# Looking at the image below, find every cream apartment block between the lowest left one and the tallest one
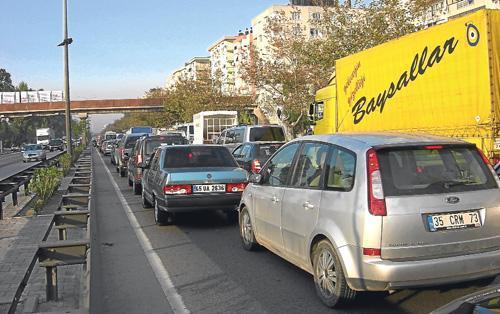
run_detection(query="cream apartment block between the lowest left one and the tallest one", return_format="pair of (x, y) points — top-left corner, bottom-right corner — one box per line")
(208, 36), (237, 95)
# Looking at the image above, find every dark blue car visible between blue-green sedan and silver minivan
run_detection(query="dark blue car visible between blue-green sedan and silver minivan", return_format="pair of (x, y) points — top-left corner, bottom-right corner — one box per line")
(233, 142), (285, 173)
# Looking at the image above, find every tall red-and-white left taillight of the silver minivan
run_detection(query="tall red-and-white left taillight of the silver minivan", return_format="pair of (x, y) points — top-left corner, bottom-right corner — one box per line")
(366, 149), (387, 216)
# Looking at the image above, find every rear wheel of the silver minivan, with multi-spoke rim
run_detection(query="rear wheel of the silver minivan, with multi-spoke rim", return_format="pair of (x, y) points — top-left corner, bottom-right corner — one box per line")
(312, 240), (356, 307)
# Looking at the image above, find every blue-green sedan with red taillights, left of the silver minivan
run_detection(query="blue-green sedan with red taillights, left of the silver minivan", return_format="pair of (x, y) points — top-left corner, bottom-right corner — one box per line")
(142, 145), (248, 225)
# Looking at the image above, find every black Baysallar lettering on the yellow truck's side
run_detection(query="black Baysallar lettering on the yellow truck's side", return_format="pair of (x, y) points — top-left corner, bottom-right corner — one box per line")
(351, 37), (459, 124)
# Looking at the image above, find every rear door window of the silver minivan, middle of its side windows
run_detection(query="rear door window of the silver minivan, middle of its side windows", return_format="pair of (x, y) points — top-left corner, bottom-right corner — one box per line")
(292, 143), (329, 188)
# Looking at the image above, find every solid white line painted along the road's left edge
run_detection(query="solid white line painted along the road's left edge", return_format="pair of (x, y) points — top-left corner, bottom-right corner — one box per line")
(98, 153), (190, 313)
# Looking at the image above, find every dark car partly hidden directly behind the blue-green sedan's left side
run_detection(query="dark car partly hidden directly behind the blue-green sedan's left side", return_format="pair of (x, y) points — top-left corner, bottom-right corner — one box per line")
(127, 135), (188, 195)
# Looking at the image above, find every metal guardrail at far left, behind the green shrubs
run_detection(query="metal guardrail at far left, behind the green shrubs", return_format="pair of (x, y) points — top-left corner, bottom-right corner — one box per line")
(0, 151), (66, 220)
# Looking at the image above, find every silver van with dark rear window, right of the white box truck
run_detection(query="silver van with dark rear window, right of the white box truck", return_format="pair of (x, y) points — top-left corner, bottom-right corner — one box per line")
(214, 124), (285, 151)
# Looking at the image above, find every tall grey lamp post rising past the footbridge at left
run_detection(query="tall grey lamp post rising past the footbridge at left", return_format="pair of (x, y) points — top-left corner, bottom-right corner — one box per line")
(58, 0), (73, 157)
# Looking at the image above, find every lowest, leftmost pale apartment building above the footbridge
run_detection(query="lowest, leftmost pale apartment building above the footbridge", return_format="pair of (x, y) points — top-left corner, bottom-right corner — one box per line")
(165, 57), (210, 89)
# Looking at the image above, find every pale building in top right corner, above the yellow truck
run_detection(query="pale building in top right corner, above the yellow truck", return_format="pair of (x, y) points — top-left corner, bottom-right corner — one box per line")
(419, 0), (500, 27)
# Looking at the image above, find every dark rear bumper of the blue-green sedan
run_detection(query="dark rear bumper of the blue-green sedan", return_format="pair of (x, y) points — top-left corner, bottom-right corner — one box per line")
(158, 193), (241, 212)
